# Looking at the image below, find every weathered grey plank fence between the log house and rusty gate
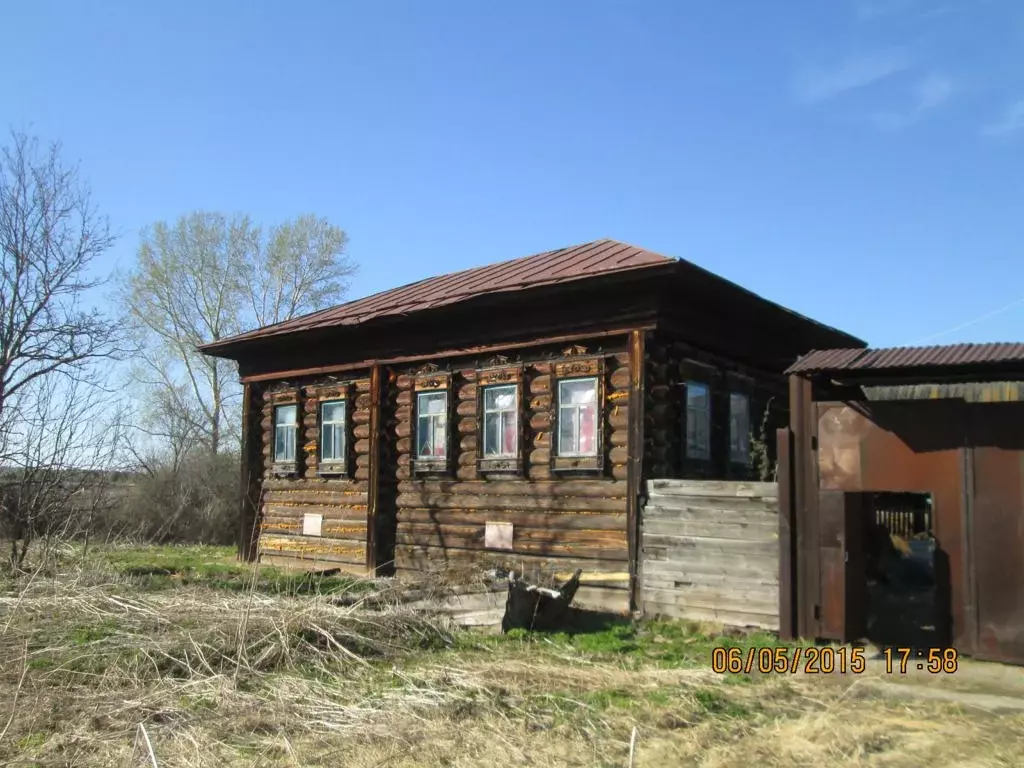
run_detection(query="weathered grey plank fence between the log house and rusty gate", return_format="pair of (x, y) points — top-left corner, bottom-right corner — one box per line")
(640, 480), (779, 630)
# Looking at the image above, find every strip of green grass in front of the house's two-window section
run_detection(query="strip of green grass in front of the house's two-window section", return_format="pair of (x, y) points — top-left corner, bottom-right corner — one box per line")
(94, 546), (369, 595)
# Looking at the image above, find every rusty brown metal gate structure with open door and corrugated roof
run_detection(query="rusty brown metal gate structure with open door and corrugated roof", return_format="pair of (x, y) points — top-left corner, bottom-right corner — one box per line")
(778, 344), (1024, 663)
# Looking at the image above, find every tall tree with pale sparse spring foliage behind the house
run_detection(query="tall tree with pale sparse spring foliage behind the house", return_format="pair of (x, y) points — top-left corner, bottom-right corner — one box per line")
(121, 212), (354, 462)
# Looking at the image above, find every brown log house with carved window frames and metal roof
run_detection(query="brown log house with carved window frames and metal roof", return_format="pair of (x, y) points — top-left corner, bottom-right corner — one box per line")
(203, 240), (863, 609)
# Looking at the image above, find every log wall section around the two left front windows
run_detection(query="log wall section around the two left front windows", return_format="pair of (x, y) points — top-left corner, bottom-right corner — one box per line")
(259, 379), (371, 572)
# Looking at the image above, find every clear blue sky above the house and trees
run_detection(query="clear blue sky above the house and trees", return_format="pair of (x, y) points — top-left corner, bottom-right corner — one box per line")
(0, 0), (1024, 345)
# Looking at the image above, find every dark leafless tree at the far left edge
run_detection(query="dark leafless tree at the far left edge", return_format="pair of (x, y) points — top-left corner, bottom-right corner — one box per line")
(0, 132), (119, 566)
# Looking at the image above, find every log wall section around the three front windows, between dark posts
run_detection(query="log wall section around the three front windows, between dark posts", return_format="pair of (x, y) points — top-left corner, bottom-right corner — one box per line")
(394, 351), (630, 610)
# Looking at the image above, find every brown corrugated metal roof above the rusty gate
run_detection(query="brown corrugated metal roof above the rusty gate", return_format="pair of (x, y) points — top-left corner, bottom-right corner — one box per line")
(786, 343), (1024, 374)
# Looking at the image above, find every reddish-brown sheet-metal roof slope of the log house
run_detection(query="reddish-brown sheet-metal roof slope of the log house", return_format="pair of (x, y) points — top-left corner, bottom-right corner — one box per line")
(200, 240), (676, 350)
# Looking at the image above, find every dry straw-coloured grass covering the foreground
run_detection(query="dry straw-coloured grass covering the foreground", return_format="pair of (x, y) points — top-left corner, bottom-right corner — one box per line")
(0, 548), (1024, 767)
